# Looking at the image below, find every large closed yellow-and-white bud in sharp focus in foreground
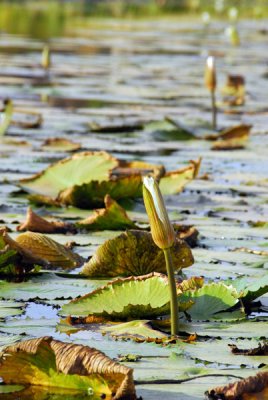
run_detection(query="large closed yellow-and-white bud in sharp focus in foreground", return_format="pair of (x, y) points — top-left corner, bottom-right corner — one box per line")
(143, 177), (175, 250)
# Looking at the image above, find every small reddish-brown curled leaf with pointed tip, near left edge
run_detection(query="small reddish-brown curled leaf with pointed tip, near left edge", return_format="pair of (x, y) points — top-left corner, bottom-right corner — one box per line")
(17, 207), (76, 233)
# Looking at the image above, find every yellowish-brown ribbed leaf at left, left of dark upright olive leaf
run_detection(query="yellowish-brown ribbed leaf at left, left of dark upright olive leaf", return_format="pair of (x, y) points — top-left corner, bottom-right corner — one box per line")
(16, 232), (82, 268)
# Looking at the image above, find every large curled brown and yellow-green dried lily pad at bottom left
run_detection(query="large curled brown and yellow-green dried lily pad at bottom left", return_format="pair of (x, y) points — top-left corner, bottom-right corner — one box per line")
(0, 337), (136, 400)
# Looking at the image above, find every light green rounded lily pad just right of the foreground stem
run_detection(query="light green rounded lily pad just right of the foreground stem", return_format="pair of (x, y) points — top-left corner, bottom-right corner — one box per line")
(180, 282), (238, 320)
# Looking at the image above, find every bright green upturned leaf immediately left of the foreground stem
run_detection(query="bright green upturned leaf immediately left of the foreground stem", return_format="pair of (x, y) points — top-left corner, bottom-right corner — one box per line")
(60, 273), (170, 319)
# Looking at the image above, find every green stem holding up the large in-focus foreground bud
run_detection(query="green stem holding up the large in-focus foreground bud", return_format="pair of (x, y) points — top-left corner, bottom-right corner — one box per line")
(163, 248), (179, 336)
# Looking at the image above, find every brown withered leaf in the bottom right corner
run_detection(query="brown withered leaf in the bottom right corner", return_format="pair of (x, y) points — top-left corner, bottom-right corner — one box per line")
(206, 372), (268, 400)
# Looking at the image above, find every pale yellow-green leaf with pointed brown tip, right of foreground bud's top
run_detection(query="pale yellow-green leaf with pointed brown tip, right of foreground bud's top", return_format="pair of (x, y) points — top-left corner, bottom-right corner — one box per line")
(159, 159), (201, 195)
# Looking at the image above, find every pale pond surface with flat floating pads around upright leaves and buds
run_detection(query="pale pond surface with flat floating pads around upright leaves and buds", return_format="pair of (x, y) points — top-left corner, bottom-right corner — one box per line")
(0, 5), (268, 400)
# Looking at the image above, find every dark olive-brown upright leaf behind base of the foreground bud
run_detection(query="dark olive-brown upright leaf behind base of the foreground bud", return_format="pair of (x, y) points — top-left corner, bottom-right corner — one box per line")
(82, 230), (194, 277)
